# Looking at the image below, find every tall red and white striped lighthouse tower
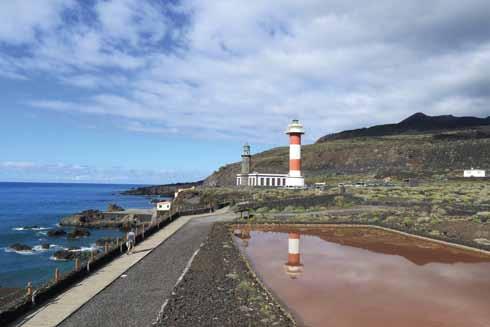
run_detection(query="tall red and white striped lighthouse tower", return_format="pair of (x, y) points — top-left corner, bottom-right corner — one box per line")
(286, 119), (305, 188)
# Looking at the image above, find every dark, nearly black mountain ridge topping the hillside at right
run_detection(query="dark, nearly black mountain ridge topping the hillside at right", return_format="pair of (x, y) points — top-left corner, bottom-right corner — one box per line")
(317, 112), (490, 143)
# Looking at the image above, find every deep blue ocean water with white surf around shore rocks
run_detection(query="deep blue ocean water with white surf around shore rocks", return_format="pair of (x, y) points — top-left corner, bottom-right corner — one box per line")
(0, 183), (152, 288)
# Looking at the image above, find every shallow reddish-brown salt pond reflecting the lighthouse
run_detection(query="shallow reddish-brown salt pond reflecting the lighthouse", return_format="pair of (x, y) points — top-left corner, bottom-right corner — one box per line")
(233, 226), (490, 327)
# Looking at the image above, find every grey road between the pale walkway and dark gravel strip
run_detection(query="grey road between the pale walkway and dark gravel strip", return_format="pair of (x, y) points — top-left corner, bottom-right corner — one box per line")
(60, 213), (233, 327)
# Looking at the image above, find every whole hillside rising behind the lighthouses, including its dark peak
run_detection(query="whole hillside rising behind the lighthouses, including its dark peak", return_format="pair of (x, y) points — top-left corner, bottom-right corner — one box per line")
(204, 114), (490, 186)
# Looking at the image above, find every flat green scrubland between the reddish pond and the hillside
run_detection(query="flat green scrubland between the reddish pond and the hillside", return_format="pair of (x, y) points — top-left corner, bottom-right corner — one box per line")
(230, 180), (490, 249)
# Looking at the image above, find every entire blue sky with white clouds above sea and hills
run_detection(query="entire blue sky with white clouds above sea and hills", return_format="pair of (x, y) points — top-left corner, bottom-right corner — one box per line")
(0, 0), (490, 184)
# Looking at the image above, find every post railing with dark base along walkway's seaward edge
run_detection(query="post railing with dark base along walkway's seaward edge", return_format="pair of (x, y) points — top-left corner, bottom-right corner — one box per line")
(0, 203), (229, 326)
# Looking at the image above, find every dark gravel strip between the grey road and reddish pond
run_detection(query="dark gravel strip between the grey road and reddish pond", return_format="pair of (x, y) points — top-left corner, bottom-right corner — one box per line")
(159, 223), (296, 326)
